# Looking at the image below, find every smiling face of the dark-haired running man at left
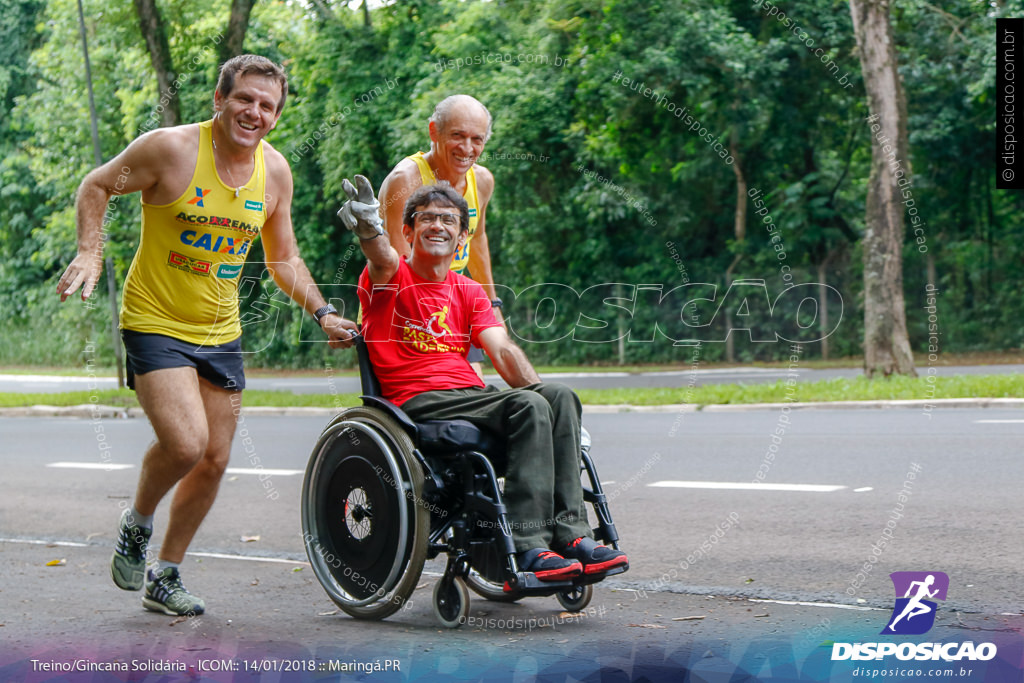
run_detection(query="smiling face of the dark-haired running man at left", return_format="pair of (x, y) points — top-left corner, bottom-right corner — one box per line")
(213, 74), (283, 148)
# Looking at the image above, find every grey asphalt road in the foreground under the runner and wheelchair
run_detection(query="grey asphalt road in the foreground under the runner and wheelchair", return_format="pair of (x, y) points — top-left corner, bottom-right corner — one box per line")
(0, 409), (1024, 681)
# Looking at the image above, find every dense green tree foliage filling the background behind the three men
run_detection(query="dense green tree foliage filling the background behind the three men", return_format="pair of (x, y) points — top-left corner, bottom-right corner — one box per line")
(0, 0), (1007, 367)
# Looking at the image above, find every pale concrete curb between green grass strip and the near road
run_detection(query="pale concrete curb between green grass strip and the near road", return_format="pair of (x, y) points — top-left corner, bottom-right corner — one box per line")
(0, 398), (1024, 420)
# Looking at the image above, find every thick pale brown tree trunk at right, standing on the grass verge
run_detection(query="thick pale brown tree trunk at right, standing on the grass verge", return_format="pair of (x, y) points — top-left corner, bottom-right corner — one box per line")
(850, 0), (918, 378)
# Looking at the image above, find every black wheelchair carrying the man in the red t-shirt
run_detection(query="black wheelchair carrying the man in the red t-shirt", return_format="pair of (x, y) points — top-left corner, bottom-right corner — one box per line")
(302, 337), (629, 628)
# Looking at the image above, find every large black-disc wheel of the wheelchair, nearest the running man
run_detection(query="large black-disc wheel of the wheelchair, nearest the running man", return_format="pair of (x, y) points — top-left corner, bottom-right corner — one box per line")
(302, 408), (430, 620)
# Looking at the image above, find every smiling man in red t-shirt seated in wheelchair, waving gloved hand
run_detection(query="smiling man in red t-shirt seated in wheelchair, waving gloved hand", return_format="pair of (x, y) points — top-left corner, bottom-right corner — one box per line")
(339, 176), (628, 581)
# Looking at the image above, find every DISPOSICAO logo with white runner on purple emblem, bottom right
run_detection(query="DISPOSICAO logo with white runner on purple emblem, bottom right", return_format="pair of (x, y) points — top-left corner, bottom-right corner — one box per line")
(831, 571), (996, 661)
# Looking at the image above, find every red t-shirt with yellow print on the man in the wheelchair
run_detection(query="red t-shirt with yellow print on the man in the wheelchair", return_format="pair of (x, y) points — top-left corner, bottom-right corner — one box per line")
(359, 258), (501, 405)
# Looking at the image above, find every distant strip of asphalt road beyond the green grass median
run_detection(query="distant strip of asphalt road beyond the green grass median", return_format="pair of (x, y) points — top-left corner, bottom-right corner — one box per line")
(0, 364), (1024, 393)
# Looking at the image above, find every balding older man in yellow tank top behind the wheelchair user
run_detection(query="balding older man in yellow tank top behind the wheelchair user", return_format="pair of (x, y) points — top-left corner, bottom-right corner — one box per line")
(379, 95), (502, 377)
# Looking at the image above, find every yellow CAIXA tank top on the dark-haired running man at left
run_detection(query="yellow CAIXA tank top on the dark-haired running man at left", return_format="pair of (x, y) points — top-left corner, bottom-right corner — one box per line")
(121, 121), (266, 345)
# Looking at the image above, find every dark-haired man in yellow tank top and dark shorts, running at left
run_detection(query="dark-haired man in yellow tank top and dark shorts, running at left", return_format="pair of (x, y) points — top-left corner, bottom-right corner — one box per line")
(57, 55), (355, 615)
